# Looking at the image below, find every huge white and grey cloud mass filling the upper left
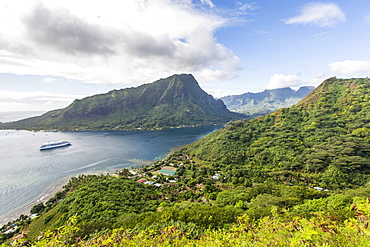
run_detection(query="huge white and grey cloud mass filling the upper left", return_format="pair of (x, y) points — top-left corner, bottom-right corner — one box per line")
(0, 0), (239, 84)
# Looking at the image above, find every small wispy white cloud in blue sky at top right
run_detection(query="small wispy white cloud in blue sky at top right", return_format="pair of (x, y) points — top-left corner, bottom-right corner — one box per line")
(283, 3), (346, 27)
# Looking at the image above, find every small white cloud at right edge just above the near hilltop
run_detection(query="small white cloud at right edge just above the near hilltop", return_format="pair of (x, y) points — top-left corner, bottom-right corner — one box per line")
(328, 60), (370, 78)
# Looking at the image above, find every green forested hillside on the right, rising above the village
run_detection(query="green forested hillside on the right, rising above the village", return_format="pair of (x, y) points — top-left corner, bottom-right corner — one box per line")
(181, 78), (370, 189)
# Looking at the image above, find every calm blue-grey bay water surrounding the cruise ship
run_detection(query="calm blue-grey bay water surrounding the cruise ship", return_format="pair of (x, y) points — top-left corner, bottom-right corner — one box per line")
(0, 126), (222, 225)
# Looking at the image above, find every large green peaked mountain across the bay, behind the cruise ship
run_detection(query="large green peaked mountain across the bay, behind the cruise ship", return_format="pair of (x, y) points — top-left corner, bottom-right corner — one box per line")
(3, 74), (243, 130)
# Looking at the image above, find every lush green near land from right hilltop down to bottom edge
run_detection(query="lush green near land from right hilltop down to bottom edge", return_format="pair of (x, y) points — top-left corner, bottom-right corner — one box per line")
(0, 78), (370, 246)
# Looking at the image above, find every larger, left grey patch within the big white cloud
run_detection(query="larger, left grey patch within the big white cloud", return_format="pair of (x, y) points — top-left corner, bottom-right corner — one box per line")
(23, 5), (117, 54)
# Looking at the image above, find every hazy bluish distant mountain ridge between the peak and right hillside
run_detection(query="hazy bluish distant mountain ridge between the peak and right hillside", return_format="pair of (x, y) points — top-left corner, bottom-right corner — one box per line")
(221, 86), (315, 117)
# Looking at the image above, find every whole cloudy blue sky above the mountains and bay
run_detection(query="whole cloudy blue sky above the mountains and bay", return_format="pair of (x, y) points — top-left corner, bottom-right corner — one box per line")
(0, 0), (370, 112)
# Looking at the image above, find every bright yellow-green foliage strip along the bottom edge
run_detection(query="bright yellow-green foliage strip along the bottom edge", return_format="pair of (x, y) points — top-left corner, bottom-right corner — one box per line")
(9, 198), (370, 247)
